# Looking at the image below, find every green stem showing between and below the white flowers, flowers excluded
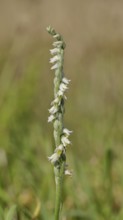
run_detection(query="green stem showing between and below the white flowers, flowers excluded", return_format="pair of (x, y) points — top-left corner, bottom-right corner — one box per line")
(54, 42), (65, 220)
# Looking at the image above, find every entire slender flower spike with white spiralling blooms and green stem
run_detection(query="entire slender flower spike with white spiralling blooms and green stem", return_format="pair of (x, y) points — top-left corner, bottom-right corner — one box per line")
(47, 26), (72, 220)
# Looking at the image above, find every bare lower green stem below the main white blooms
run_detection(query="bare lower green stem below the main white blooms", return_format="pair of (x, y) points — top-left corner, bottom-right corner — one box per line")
(54, 162), (65, 220)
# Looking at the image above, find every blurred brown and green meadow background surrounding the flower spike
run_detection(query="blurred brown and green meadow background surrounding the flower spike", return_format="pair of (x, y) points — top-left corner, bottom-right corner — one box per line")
(0, 0), (123, 220)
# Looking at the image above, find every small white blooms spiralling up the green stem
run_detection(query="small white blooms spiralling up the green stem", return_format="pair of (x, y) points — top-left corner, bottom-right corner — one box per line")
(48, 34), (72, 175)
